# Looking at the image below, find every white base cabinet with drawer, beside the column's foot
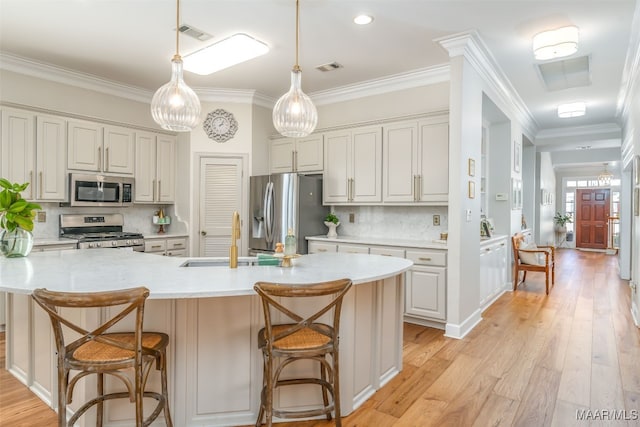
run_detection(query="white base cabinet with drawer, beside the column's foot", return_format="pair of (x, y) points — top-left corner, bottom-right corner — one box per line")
(405, 249), (447, 324)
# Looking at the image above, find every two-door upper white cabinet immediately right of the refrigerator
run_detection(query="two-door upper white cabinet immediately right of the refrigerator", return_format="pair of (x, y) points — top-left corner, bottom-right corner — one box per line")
(323, 126), (382, 204)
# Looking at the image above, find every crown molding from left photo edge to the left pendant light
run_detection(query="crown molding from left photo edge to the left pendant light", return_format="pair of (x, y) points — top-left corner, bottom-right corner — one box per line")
(0, 52), (153, 104)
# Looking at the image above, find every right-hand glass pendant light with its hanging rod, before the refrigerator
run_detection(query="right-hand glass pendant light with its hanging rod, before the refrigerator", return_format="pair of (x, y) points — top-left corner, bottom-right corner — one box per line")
(273, 0), (318, 138)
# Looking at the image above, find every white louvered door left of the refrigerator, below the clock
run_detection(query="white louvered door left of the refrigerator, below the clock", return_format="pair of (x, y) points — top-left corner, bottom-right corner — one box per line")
(200, 157), (243, 257)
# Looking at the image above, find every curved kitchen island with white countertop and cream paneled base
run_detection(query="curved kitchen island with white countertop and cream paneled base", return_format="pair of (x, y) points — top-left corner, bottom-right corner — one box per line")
(0, 249), (411, 426)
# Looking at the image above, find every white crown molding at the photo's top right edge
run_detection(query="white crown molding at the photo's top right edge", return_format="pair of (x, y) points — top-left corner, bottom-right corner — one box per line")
(616, 3), (640, 123)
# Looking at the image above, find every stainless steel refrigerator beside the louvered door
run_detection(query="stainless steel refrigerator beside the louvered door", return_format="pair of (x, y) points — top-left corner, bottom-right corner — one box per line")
(249, 173), (329, 254)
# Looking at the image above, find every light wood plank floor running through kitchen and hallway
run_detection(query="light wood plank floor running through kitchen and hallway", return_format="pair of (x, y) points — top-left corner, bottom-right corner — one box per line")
(0, 250), (640, 427)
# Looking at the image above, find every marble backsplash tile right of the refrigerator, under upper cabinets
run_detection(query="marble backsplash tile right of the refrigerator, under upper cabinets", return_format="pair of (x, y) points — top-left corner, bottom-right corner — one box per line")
(334, 206), (448, 240)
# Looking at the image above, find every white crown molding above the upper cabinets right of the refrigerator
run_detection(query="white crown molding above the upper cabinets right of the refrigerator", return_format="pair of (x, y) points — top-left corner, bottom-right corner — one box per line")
(309, 64), (450, 105)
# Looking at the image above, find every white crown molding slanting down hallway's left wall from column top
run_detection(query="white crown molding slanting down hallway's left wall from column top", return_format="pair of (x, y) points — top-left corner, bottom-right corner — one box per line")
(434, 30), (539, 139)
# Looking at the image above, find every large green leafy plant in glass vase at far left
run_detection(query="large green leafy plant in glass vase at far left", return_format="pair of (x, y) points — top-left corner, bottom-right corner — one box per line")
(0, 178), (42, 231)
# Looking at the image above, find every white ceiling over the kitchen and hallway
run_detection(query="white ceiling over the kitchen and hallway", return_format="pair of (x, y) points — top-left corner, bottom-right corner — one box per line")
(0, 0), (640, 155)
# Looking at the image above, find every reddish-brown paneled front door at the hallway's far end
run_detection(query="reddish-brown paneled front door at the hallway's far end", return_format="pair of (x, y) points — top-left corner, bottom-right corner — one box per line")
(576, 188), (610, 249)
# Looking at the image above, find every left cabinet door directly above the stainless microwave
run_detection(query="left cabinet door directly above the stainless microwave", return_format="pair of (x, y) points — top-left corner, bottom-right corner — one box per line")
(67, 120), (103, 172)
